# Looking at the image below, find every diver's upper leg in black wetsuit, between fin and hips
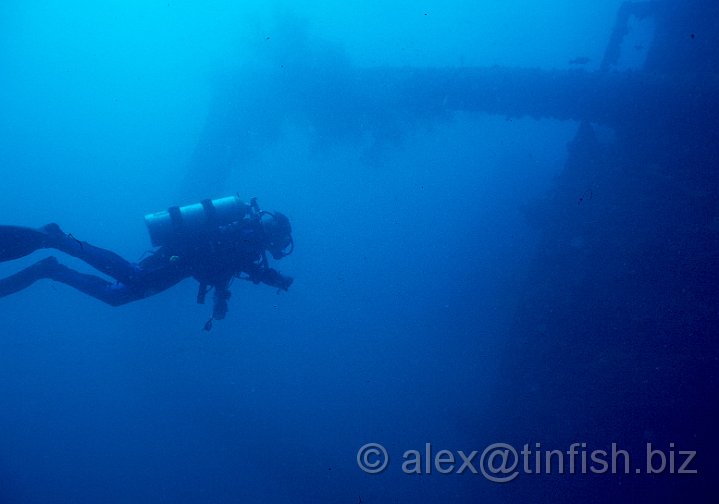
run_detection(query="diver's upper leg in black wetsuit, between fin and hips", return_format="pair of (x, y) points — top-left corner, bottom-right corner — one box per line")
(42, 223), (138, 284)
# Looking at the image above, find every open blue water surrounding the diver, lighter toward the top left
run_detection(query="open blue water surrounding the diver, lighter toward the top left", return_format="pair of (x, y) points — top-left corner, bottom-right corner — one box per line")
(0, 0), (716, 504)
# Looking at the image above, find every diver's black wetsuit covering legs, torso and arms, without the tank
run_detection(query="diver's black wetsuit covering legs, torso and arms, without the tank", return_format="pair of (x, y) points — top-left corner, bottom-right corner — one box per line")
(0, 219), (292, 319)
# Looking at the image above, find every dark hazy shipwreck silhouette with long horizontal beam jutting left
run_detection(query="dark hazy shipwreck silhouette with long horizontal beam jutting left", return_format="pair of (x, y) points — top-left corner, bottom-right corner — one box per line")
(187, 0), (719, 504)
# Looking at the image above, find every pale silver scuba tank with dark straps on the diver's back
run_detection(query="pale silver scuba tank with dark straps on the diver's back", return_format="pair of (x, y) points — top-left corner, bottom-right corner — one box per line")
(145, 196), (257, 247)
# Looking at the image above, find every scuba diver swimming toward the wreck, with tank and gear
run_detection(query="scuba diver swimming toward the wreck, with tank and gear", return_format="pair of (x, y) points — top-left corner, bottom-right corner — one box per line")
(0, 196), (294, 331)
